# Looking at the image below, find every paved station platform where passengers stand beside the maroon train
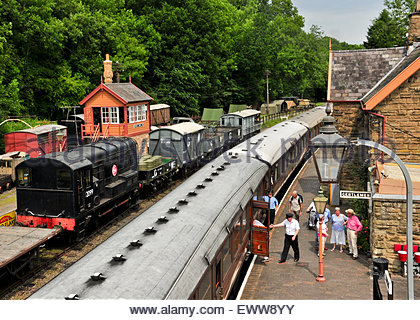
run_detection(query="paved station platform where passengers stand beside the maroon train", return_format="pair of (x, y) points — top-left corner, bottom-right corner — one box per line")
(238, 160), (420, 300)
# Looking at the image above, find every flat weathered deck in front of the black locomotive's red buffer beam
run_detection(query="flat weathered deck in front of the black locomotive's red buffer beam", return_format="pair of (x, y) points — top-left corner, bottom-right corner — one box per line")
(0, 226), (61, 275)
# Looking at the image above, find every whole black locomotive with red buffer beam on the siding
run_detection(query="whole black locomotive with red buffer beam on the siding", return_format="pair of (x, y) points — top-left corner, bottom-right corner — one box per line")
(16, 138), (138, 234)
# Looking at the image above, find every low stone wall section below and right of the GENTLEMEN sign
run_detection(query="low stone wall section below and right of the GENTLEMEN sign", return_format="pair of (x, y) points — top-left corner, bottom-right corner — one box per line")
(370, 200), (420, 272)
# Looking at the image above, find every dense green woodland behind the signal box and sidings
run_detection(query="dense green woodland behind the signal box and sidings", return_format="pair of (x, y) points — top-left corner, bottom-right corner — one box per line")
(0, 0), (364, 120)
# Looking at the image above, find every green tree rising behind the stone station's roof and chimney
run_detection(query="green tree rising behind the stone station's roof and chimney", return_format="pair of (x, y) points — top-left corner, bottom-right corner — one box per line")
(364, 0), (416, 49)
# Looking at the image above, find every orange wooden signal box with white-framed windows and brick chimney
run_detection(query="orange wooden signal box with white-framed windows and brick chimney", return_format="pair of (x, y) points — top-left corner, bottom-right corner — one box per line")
(79, 54), (153, 153)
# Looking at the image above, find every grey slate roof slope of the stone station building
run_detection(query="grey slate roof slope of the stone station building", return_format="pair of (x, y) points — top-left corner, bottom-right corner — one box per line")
(330, 47), (405, 100)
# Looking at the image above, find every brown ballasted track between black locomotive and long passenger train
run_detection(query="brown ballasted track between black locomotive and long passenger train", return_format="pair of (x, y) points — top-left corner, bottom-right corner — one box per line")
(0, 179), (184, 300)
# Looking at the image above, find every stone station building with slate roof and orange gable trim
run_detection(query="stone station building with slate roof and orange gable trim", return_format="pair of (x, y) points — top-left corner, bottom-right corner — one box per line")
(327, 0), (420, 271)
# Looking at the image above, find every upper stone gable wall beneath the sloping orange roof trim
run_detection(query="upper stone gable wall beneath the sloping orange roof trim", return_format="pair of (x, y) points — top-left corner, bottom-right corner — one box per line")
(370, 70), (420, 163)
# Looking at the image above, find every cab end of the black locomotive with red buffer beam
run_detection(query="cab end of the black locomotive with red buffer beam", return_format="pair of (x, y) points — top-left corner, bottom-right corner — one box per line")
(16, 153), (94, 230)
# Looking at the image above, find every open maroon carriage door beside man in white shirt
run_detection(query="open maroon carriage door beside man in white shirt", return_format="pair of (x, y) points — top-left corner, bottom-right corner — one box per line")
(250, 198), (270, 257)
